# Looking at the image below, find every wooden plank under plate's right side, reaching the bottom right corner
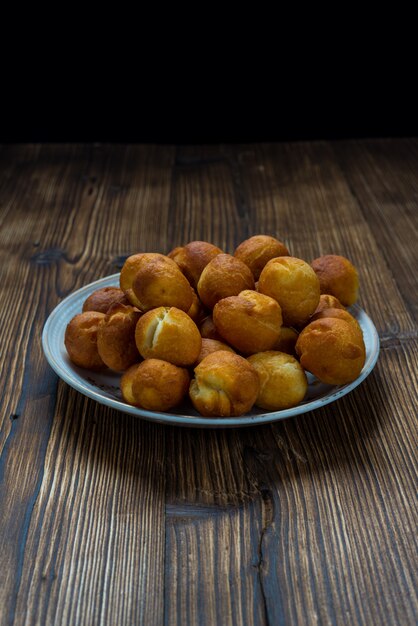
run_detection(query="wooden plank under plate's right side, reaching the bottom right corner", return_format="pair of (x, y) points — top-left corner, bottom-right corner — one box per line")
(232, 144), (417, 624)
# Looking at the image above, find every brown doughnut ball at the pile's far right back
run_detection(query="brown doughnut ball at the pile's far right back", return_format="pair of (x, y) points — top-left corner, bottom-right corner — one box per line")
(311, 254), (359, 306)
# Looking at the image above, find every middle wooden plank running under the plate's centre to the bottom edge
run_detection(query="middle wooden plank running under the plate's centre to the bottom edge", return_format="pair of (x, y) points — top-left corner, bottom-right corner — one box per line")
(165, 152), (264, 625)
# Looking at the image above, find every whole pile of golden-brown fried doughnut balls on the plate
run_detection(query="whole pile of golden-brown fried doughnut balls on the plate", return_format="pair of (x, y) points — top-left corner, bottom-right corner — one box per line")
(65, 235), (366, 417)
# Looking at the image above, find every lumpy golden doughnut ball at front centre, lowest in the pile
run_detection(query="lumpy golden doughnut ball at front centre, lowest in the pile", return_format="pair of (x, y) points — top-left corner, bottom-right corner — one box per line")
(189, 351), (260, 417)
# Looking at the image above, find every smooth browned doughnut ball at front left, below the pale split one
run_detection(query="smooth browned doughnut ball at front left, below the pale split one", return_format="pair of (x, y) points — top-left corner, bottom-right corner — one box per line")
(120, 359), (190, 411)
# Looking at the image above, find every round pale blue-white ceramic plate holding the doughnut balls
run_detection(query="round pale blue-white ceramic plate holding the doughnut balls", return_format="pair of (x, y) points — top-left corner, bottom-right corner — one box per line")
(42, 274), (379, 428)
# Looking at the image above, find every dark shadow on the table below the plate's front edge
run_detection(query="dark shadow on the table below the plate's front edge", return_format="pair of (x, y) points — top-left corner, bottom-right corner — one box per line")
(63, 360), (388, 512)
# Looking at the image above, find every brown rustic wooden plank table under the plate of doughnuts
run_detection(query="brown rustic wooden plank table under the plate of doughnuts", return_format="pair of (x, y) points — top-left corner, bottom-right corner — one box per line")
(0, 139), (418, 626)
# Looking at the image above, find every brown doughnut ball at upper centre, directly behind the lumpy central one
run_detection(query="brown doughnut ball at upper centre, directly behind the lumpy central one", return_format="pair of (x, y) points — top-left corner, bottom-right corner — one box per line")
(197, 254), (254, 309)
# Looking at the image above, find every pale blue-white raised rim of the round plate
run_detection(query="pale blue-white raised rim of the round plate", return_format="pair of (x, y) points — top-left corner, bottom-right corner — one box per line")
(42, 273), (380, 428)
